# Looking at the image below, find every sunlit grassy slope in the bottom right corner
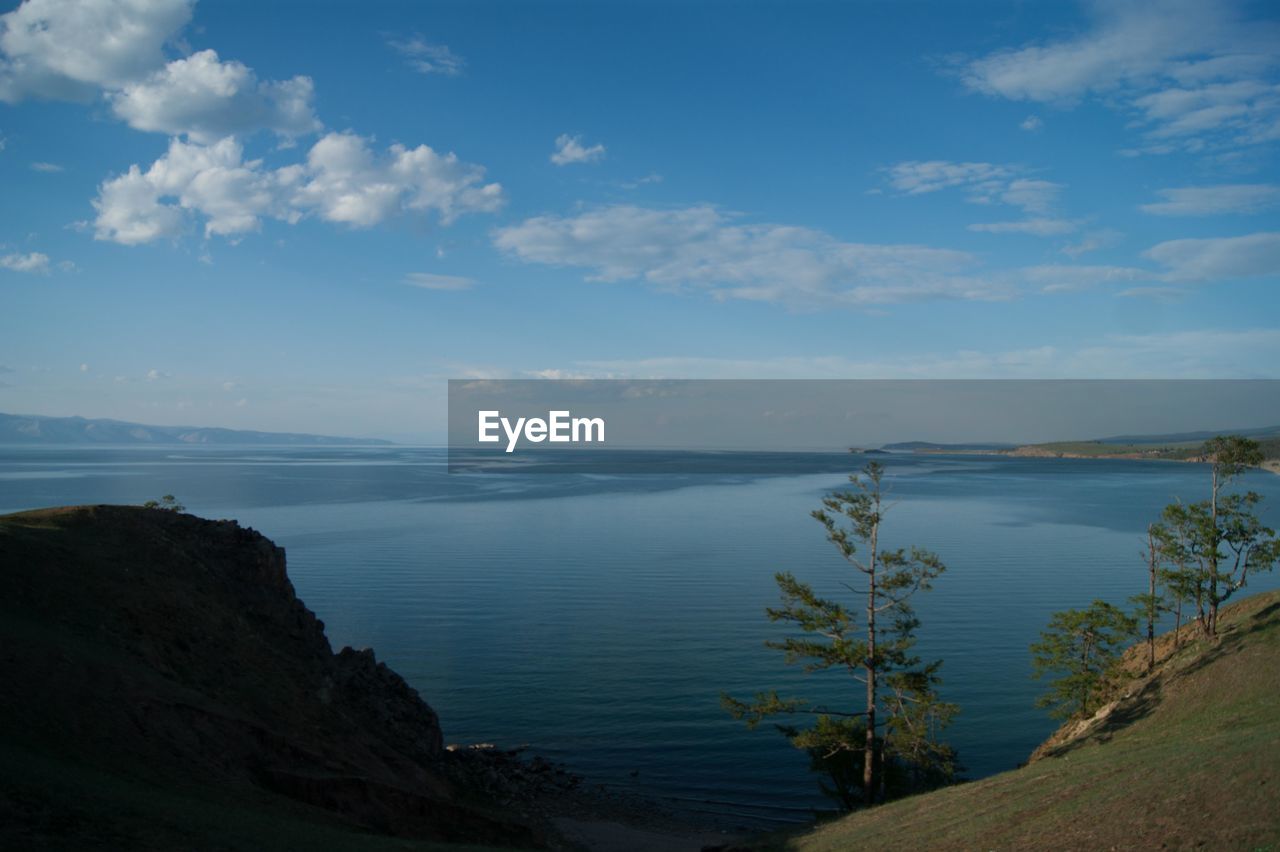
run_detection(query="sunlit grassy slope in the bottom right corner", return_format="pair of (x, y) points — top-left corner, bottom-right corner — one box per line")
(764, 592), (1280, 852)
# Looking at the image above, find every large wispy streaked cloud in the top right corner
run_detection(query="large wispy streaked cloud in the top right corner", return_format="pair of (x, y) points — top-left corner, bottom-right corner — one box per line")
(963, 0), (1280, 151)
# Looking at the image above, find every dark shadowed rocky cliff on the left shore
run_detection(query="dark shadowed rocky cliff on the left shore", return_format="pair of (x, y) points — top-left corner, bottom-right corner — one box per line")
(0, 505), (538, 847)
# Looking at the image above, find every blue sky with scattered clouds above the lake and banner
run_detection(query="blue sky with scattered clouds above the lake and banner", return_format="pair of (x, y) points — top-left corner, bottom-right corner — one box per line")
(0, 0), (1280, 440)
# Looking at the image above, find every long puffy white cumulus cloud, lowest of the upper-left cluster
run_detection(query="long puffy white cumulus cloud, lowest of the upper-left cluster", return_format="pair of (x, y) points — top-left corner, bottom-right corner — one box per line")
(93, 133), (503, 246)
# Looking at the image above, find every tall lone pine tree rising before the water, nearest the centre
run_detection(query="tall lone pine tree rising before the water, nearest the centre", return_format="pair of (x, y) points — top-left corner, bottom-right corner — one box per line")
(721, 462), (957, 807)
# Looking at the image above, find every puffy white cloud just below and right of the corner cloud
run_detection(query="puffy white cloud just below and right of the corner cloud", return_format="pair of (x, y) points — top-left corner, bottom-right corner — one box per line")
(108, 50), (320, 143)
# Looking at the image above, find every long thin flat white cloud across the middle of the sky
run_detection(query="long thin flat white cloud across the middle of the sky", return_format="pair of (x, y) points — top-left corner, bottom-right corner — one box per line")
(494, 205), (1014, 307)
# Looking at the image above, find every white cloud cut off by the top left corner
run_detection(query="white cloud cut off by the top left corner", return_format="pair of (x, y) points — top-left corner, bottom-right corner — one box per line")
(0, 0), (193, 104)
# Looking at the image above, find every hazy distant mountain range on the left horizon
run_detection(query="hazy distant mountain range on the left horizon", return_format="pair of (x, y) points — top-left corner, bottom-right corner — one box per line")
(0, 413), (392, 446)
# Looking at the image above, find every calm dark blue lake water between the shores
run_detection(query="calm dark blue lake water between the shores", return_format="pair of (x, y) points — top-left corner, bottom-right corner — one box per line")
(0, 446), (1280, 817)
